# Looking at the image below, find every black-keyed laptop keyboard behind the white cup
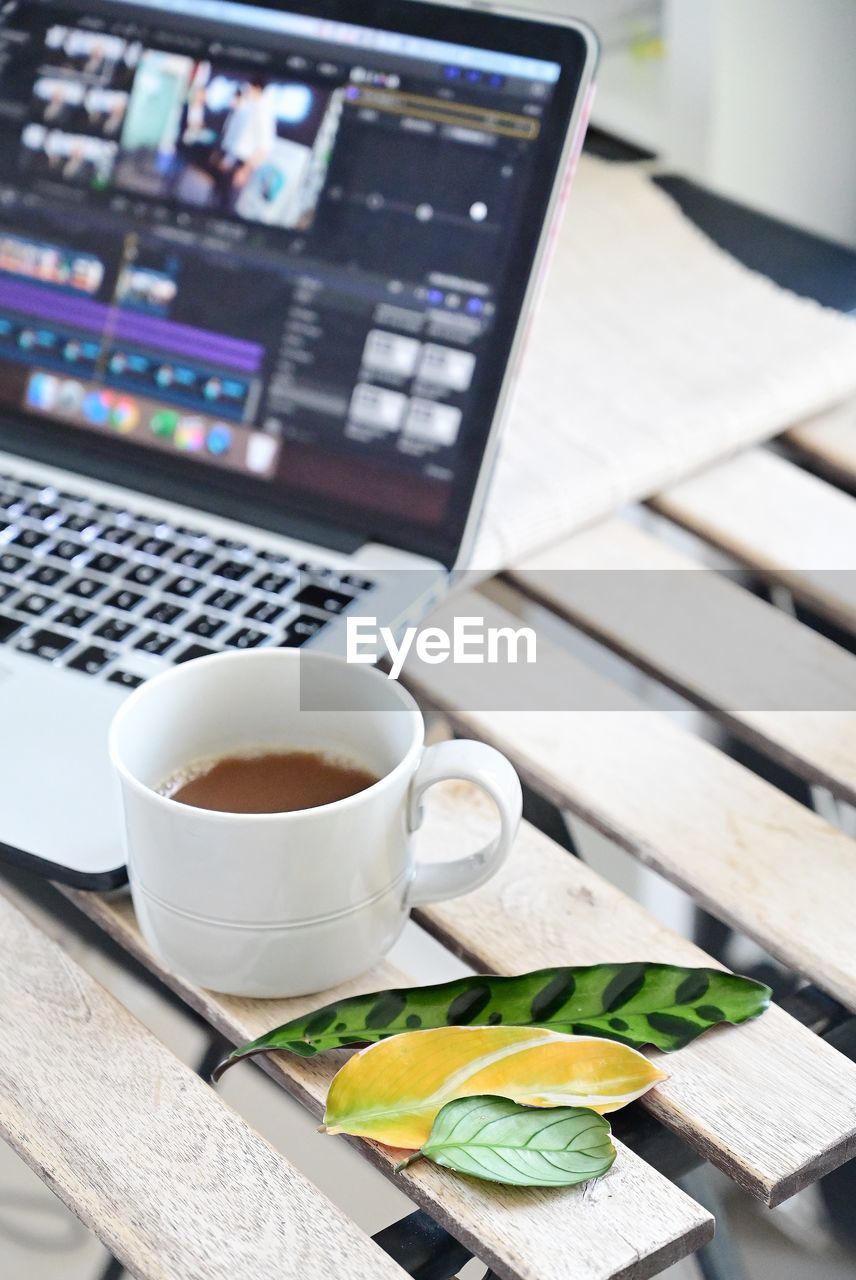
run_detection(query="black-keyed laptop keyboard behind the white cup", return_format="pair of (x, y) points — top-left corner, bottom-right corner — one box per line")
(0, 476), (374, 689)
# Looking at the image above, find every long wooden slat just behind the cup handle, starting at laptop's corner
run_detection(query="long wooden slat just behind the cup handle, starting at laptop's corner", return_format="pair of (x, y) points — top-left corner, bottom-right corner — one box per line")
(406, 595), (856, 1009)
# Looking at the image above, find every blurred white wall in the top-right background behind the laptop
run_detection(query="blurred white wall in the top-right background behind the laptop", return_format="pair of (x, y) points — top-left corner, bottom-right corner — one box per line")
(493, 0), (856, 244)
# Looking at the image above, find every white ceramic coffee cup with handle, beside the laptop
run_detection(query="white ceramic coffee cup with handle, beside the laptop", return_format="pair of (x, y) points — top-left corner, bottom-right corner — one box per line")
(110, 649), (522, 996)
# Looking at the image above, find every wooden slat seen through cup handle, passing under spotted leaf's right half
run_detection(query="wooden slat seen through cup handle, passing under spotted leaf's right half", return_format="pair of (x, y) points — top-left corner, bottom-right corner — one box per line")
(422, 787), (856, 1204)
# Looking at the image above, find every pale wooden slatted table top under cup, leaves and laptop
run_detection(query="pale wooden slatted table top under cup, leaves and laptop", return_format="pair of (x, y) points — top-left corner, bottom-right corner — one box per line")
(0, 167), (856, 1280)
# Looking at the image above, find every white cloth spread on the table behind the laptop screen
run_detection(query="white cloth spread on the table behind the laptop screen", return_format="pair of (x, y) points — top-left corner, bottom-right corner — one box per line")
(472, 157), (856, 570)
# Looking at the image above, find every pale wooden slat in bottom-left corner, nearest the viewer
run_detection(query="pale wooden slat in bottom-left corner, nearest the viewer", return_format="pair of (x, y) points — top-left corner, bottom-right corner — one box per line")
(0, 895), (404, 1280)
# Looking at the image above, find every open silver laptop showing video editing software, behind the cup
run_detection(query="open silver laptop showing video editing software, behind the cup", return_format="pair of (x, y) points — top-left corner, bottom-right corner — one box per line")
(0, 0), (596, 890)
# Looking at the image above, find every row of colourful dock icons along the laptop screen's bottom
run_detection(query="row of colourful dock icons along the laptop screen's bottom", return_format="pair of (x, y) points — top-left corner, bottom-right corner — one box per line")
(24, 369), (280, 479)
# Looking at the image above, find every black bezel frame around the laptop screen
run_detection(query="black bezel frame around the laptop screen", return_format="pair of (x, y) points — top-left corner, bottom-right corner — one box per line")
(0, 0), (592, 567)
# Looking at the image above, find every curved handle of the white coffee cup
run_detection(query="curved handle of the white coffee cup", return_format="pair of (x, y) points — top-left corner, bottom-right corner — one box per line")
(407, 741), (523, 906)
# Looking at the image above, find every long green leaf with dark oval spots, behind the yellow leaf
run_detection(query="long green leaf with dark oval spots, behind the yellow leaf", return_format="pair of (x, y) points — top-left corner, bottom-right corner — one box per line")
(214, 963), (772, 1079)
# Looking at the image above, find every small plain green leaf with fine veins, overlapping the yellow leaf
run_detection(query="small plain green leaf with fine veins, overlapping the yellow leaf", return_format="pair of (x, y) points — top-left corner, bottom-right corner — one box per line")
(399, 1097), (615, 1187)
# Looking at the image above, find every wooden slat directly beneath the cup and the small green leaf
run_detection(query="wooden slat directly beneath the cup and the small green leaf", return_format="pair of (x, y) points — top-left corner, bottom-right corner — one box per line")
(64, 890), (713, 1280)
